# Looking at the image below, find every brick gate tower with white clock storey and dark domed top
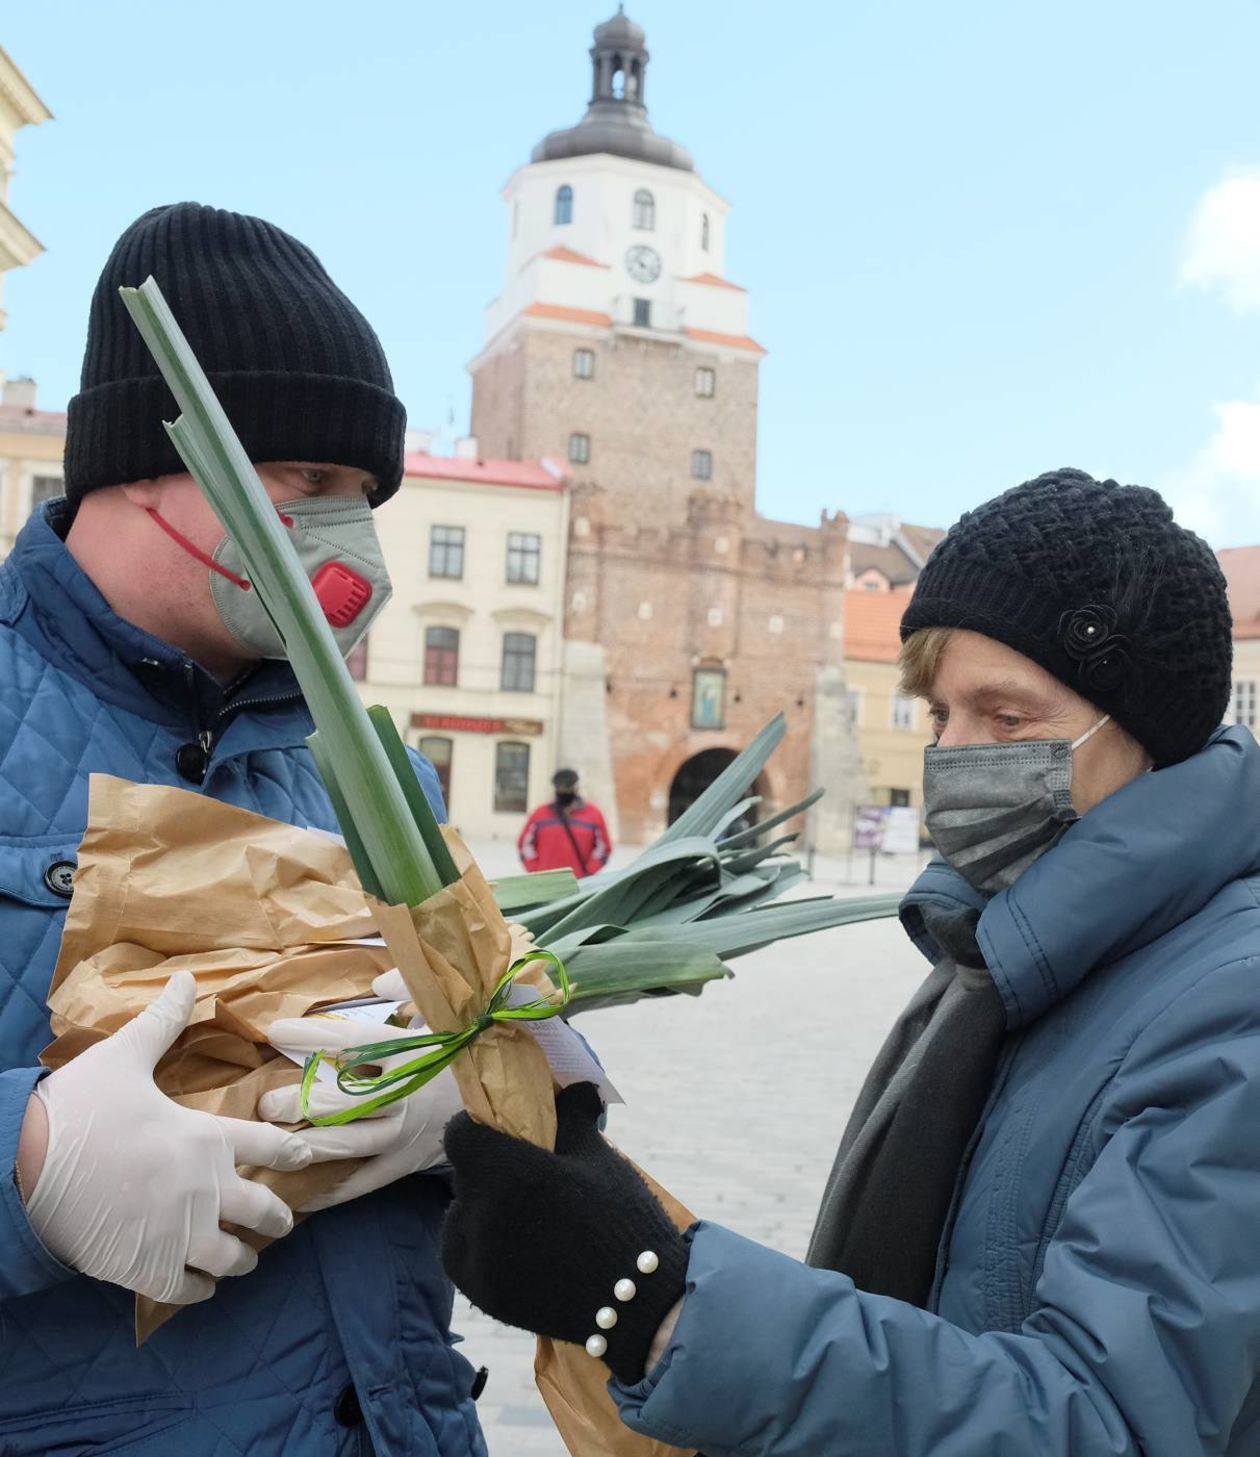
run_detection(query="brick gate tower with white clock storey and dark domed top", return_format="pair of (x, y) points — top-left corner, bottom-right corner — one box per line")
(470, 13), (861, 848)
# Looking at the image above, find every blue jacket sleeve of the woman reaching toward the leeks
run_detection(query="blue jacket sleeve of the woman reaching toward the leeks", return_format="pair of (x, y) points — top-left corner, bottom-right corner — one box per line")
(613, 959), (1260, 1457)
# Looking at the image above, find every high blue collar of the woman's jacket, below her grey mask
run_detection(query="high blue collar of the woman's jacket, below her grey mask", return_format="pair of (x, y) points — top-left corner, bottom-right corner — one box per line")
(902, 729), (1260, 1029)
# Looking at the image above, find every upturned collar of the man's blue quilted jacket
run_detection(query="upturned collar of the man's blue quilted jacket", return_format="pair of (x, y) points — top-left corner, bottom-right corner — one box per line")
(0, 500), (300, 730)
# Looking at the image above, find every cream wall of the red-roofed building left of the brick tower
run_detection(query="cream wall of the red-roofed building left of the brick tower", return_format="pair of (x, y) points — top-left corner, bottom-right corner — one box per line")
(360, 456), (568, 839)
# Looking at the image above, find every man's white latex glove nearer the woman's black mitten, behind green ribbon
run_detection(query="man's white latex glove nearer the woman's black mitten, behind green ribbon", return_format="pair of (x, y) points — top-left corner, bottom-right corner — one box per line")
(258, 1002), (463, 1214)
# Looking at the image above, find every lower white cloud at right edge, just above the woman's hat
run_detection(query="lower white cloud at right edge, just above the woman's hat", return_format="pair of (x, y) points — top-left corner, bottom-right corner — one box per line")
(1159, 392), (1260, 548)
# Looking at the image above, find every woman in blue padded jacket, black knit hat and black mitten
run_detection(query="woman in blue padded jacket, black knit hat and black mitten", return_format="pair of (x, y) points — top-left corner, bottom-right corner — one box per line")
(444, 471), (1260, 1457)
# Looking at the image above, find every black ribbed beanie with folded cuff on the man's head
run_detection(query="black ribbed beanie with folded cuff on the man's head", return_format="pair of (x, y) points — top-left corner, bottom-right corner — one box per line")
(66, 203), (406, 504)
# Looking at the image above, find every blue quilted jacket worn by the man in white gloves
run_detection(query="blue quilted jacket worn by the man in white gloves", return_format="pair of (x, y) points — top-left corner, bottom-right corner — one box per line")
(0, 503), (485, 1457)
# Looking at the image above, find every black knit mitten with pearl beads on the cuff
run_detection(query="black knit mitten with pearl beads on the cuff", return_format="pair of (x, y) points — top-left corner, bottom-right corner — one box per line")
(441, 1083), (688, 1383)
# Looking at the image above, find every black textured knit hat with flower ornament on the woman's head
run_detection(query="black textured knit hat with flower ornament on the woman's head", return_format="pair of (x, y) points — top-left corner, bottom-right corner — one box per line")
(902, 471), (1232, 766)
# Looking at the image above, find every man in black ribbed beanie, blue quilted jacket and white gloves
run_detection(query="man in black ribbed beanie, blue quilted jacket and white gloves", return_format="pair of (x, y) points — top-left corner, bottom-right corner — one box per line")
(0, 203), (485, 1457)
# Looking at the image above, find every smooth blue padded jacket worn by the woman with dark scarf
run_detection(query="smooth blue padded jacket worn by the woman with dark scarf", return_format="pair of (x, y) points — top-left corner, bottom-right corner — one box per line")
(618, 729), (1260, 1457)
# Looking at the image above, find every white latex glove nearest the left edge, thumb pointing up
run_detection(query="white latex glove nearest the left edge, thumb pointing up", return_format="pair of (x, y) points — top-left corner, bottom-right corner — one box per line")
(26, 972), (310, 1305)
